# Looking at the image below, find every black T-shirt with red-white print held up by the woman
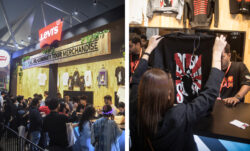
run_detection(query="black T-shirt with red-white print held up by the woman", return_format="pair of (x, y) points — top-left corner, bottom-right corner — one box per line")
(149, 33), (214, 103)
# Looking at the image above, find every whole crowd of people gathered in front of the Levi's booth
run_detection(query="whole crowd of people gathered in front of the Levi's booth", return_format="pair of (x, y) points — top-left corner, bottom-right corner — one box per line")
(0, 91), (125, 151)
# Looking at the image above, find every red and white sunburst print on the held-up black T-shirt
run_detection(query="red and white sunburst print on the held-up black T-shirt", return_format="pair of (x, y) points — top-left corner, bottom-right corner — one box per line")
(174, 53), (202, 103)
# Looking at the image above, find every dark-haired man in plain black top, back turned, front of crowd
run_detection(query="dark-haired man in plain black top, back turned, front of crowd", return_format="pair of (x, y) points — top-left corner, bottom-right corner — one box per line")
(43, 98), (71, 151)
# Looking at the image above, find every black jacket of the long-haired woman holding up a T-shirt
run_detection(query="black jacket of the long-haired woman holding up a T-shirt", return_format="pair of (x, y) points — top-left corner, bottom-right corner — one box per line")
(129, 59), (224, 151)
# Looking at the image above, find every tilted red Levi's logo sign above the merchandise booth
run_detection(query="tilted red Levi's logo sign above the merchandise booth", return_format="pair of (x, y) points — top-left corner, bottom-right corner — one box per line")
(39, 19), (63, 48)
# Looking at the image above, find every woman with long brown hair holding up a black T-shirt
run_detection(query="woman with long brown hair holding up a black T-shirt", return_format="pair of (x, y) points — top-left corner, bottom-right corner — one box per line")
(130, 36), (226, 151)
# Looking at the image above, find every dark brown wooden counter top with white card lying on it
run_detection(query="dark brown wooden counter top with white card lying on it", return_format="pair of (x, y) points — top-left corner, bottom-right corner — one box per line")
(194, 101), (250, 144)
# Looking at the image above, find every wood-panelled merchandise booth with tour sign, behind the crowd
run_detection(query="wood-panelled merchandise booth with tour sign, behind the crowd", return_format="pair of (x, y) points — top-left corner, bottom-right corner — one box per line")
(11, 6), (125, 107)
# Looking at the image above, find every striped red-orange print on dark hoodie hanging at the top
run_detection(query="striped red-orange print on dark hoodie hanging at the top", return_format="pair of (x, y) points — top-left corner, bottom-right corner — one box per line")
(194, 0), (208, 16)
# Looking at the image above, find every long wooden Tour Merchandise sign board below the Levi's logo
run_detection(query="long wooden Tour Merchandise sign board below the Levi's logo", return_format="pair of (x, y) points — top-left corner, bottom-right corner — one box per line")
(22, 30), (111, 69)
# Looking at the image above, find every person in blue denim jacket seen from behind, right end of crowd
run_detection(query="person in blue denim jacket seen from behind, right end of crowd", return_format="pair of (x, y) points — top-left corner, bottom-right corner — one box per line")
(91, 105), (122, 151)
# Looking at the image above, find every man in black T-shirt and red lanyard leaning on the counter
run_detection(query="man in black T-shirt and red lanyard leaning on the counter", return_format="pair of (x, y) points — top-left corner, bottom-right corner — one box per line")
(218, 44), (250, 105)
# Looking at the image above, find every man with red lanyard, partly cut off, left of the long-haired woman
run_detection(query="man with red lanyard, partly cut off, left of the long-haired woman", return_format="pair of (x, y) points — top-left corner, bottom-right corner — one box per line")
(129, 33), (143, 78)
